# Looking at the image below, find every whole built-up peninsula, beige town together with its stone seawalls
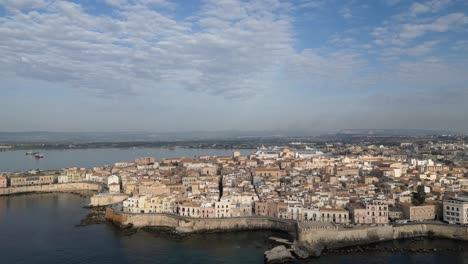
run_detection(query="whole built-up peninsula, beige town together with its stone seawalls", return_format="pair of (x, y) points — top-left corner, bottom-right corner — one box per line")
(0, 137), (468, 263)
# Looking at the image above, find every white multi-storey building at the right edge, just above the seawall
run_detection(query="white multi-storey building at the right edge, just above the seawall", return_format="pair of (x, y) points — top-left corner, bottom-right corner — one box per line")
(443, 196), (468, 225)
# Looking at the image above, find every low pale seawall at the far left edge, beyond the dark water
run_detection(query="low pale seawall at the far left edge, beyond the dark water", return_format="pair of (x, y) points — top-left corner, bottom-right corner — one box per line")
(0, 182), (101, 196)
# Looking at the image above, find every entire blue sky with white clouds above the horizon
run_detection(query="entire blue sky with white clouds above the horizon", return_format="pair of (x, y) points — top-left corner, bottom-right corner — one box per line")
(0, 0), (468, 133)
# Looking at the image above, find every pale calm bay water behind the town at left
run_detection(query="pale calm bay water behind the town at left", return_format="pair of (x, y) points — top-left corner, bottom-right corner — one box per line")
(0, 148), (255, 172)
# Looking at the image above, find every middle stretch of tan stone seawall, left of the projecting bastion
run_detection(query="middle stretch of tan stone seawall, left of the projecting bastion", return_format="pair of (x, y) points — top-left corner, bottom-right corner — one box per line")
(106, 208), (296, 236)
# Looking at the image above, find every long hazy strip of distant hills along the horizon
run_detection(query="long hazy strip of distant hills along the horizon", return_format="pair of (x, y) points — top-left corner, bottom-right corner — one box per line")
(0, 129), (454, 143)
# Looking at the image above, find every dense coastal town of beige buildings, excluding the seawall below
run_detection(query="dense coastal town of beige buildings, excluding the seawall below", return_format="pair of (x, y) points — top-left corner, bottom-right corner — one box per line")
(0, 136), (468, 226)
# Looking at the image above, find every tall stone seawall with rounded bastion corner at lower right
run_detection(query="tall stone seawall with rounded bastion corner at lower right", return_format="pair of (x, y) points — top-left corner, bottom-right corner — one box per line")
(297, 223), (468, 256)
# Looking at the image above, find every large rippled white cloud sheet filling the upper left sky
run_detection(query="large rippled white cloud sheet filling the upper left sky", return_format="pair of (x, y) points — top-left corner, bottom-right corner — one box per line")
(0, 0), (293, 98)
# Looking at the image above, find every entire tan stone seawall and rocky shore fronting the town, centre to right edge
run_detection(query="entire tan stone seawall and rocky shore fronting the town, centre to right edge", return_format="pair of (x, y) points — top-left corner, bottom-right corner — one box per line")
(106, 208), (468, 262)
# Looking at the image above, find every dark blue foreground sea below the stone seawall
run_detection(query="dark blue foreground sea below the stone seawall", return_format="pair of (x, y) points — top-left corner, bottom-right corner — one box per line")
(0, 193), (468, 264)
